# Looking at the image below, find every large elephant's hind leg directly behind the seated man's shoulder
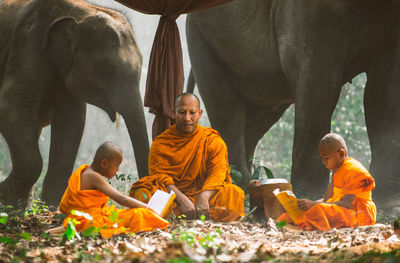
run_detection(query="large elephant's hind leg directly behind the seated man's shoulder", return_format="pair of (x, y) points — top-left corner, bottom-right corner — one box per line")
(187, 18), (250, 187)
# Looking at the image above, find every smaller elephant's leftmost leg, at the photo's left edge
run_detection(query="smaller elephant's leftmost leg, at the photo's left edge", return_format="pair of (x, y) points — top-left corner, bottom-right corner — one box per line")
(0, 125), (43, 209)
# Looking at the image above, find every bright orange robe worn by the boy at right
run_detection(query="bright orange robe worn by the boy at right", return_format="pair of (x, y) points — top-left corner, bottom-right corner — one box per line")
(278, 157), (376, 230)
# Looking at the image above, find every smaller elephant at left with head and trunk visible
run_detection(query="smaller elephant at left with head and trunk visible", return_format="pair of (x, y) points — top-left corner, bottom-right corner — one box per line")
(0, 0), (149, 210)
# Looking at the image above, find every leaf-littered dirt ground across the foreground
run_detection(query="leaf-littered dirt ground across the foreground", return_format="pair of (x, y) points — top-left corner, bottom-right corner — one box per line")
(0, 212), (400, 263)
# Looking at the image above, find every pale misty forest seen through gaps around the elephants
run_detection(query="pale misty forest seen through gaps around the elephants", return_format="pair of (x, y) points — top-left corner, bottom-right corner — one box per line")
(0, 0), (371, 199)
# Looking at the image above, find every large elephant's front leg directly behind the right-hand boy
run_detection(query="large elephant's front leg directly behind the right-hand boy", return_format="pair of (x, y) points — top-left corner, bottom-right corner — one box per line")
(291, 74), (341, 198)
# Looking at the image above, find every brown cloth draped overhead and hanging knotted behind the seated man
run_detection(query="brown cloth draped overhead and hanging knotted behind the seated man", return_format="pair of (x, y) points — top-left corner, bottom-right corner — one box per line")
(116, 0), (232, 139)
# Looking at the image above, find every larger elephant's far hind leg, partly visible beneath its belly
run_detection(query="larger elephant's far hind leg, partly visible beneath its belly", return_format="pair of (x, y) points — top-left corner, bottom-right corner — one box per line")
(245, 104), (290, 169)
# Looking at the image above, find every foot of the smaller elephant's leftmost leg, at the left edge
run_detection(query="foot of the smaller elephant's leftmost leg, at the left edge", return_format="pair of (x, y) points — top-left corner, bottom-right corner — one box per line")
(0, 177), (33, 210)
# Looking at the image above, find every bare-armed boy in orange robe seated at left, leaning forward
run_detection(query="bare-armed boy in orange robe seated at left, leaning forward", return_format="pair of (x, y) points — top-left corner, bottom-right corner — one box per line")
(60, 142), (169, 238)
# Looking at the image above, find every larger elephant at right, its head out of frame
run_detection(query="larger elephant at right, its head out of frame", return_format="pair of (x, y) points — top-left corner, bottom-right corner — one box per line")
(186, 0), (400, 214)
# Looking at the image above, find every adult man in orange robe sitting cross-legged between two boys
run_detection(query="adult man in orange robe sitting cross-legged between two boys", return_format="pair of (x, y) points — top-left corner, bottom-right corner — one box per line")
(130, 93), (244, 221)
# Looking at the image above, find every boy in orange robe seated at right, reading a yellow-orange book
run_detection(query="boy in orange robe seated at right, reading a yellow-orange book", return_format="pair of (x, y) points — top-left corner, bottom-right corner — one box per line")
(278, 133), (376, 230)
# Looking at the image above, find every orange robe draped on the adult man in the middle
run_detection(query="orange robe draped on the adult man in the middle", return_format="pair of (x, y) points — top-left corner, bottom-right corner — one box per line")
(130, 125), (244, 221)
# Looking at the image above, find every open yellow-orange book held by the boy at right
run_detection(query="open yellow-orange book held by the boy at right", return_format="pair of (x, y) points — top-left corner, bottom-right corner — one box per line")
(273, 188), (305, 224)
